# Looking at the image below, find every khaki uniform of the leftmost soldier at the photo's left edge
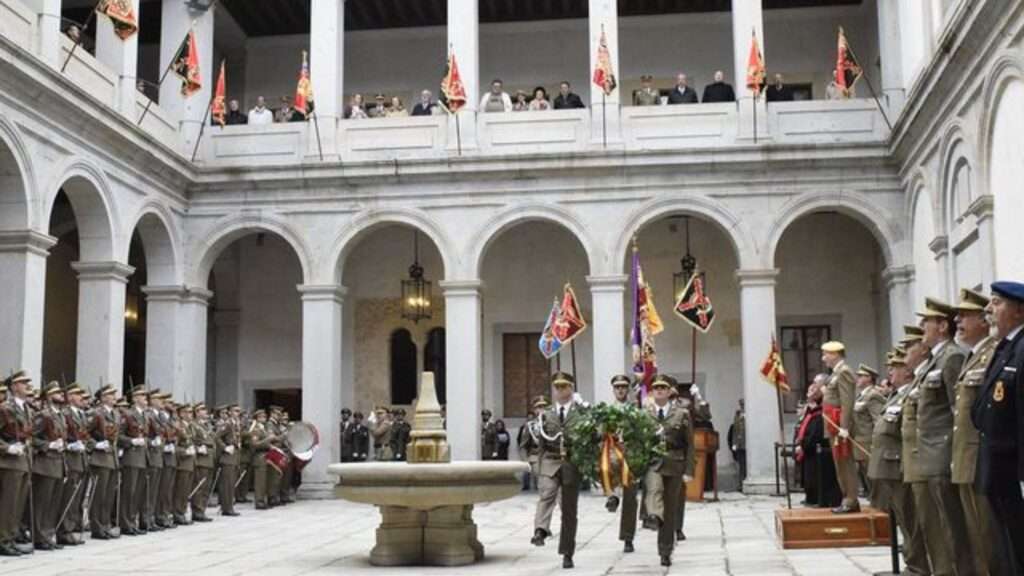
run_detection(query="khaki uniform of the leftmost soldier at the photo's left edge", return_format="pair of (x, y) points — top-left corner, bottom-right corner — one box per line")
(0, 397), (32, 547)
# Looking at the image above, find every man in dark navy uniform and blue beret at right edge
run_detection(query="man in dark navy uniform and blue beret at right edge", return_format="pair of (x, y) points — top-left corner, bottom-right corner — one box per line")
(971, 281), (1024, 574)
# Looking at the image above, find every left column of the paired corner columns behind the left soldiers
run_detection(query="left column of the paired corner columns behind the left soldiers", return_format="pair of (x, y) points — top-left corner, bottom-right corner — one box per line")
(142, 286), (188, 391)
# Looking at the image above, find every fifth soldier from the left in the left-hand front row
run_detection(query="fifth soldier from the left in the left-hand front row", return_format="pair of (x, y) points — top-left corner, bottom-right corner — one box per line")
(118, 385), (148, 536)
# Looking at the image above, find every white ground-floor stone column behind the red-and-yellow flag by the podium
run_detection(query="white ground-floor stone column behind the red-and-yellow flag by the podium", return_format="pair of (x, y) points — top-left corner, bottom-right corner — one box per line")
(736, 270), (780, 493)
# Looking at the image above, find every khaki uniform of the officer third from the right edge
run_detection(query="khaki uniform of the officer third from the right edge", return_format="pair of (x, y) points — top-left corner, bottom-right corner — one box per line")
(918, 340), (974, 575)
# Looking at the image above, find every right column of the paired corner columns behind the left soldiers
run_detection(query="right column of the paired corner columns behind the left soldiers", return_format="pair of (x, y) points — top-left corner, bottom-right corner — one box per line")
(174, 286), (213, 402)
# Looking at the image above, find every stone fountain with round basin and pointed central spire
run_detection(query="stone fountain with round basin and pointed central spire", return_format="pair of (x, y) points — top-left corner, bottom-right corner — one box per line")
(328, 372), (529, 566)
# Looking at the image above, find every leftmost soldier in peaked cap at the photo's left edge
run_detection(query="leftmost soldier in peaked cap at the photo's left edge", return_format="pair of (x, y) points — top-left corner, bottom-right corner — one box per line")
(0, 371), (32, 557)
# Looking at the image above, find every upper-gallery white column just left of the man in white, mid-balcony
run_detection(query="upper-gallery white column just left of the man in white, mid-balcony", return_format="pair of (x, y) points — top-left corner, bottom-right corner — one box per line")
(444, 0), (479, 151)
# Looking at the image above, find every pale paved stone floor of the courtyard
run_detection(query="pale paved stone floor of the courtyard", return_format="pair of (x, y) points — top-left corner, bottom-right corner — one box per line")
(0, 487), (890, 576)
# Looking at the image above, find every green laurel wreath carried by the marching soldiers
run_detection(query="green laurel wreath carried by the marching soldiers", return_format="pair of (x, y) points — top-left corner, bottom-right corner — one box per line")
(567, 402), (666, 483)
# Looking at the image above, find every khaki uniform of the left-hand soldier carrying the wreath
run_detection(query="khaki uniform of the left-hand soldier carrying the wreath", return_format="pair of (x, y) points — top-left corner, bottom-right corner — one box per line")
(534, 403), (580, 557)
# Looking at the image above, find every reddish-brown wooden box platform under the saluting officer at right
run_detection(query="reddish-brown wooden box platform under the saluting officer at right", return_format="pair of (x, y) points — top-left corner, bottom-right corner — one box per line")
(775, 507), (890, 548)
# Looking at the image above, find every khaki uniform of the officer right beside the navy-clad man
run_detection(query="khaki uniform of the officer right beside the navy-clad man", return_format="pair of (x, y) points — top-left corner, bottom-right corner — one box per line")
(951, 337), (996, 574)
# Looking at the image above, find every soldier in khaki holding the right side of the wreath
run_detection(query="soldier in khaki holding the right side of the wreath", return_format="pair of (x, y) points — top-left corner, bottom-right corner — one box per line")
(644, 374), (693, 566)
